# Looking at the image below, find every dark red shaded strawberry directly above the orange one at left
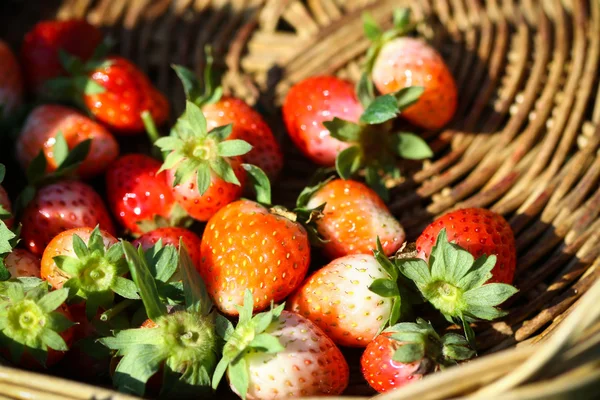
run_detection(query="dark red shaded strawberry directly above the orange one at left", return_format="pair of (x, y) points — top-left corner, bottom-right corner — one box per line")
(21, 181), (115, 255)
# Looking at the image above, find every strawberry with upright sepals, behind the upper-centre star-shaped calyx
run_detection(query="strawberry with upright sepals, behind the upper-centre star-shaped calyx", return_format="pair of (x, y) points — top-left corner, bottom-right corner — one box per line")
(173, 63), (283, 179)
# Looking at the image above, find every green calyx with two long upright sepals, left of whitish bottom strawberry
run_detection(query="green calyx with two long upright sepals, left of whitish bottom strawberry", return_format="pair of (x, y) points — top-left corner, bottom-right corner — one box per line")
(100, 241), (219, 398)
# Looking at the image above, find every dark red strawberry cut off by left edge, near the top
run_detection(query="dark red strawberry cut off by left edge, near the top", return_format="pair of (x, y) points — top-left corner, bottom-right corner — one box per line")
(0, 40), (23, 119)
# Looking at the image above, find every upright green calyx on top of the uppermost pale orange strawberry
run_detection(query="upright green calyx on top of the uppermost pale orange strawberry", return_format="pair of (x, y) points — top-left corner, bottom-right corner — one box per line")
(359, 8), (416, 79)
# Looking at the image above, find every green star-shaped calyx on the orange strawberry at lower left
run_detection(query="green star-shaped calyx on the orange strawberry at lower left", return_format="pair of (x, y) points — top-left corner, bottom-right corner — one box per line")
(53, 227), (139, 320)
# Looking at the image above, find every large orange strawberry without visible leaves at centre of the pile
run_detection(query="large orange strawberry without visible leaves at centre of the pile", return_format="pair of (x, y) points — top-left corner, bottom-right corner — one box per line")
(200, 200), (310, 315)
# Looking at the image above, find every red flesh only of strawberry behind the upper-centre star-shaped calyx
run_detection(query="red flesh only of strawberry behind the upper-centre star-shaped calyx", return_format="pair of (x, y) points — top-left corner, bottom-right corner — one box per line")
(202, 97), (283, 179)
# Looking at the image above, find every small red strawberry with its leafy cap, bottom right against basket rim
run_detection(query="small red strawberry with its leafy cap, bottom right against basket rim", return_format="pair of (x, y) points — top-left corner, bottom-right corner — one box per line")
(360, 319), (475, 393)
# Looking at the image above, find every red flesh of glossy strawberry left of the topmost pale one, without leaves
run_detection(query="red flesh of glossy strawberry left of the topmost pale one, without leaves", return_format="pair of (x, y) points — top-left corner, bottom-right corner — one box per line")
(282, 76), (363, 167)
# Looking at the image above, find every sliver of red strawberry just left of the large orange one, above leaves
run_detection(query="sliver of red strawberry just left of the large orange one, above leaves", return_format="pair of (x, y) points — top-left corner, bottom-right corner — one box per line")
(133, 227), (202, 269)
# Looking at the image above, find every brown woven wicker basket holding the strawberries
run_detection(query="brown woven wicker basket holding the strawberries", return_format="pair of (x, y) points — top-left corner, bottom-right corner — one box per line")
(0, 0), (600, 399)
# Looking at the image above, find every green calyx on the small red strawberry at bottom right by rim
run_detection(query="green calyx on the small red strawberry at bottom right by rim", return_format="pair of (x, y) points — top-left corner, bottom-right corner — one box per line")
(384, 318), (475, 374)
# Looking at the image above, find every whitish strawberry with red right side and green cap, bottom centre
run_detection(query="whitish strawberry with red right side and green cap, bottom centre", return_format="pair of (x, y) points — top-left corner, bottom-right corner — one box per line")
(213, 290), (349, 400)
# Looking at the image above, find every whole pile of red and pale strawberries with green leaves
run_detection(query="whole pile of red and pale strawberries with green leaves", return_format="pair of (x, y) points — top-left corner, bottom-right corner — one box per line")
(0, 10), (516, 399)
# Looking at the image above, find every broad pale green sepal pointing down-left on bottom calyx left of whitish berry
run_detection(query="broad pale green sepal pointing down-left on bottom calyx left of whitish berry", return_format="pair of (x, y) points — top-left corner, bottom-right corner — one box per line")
(113, 345), (165, 396)
